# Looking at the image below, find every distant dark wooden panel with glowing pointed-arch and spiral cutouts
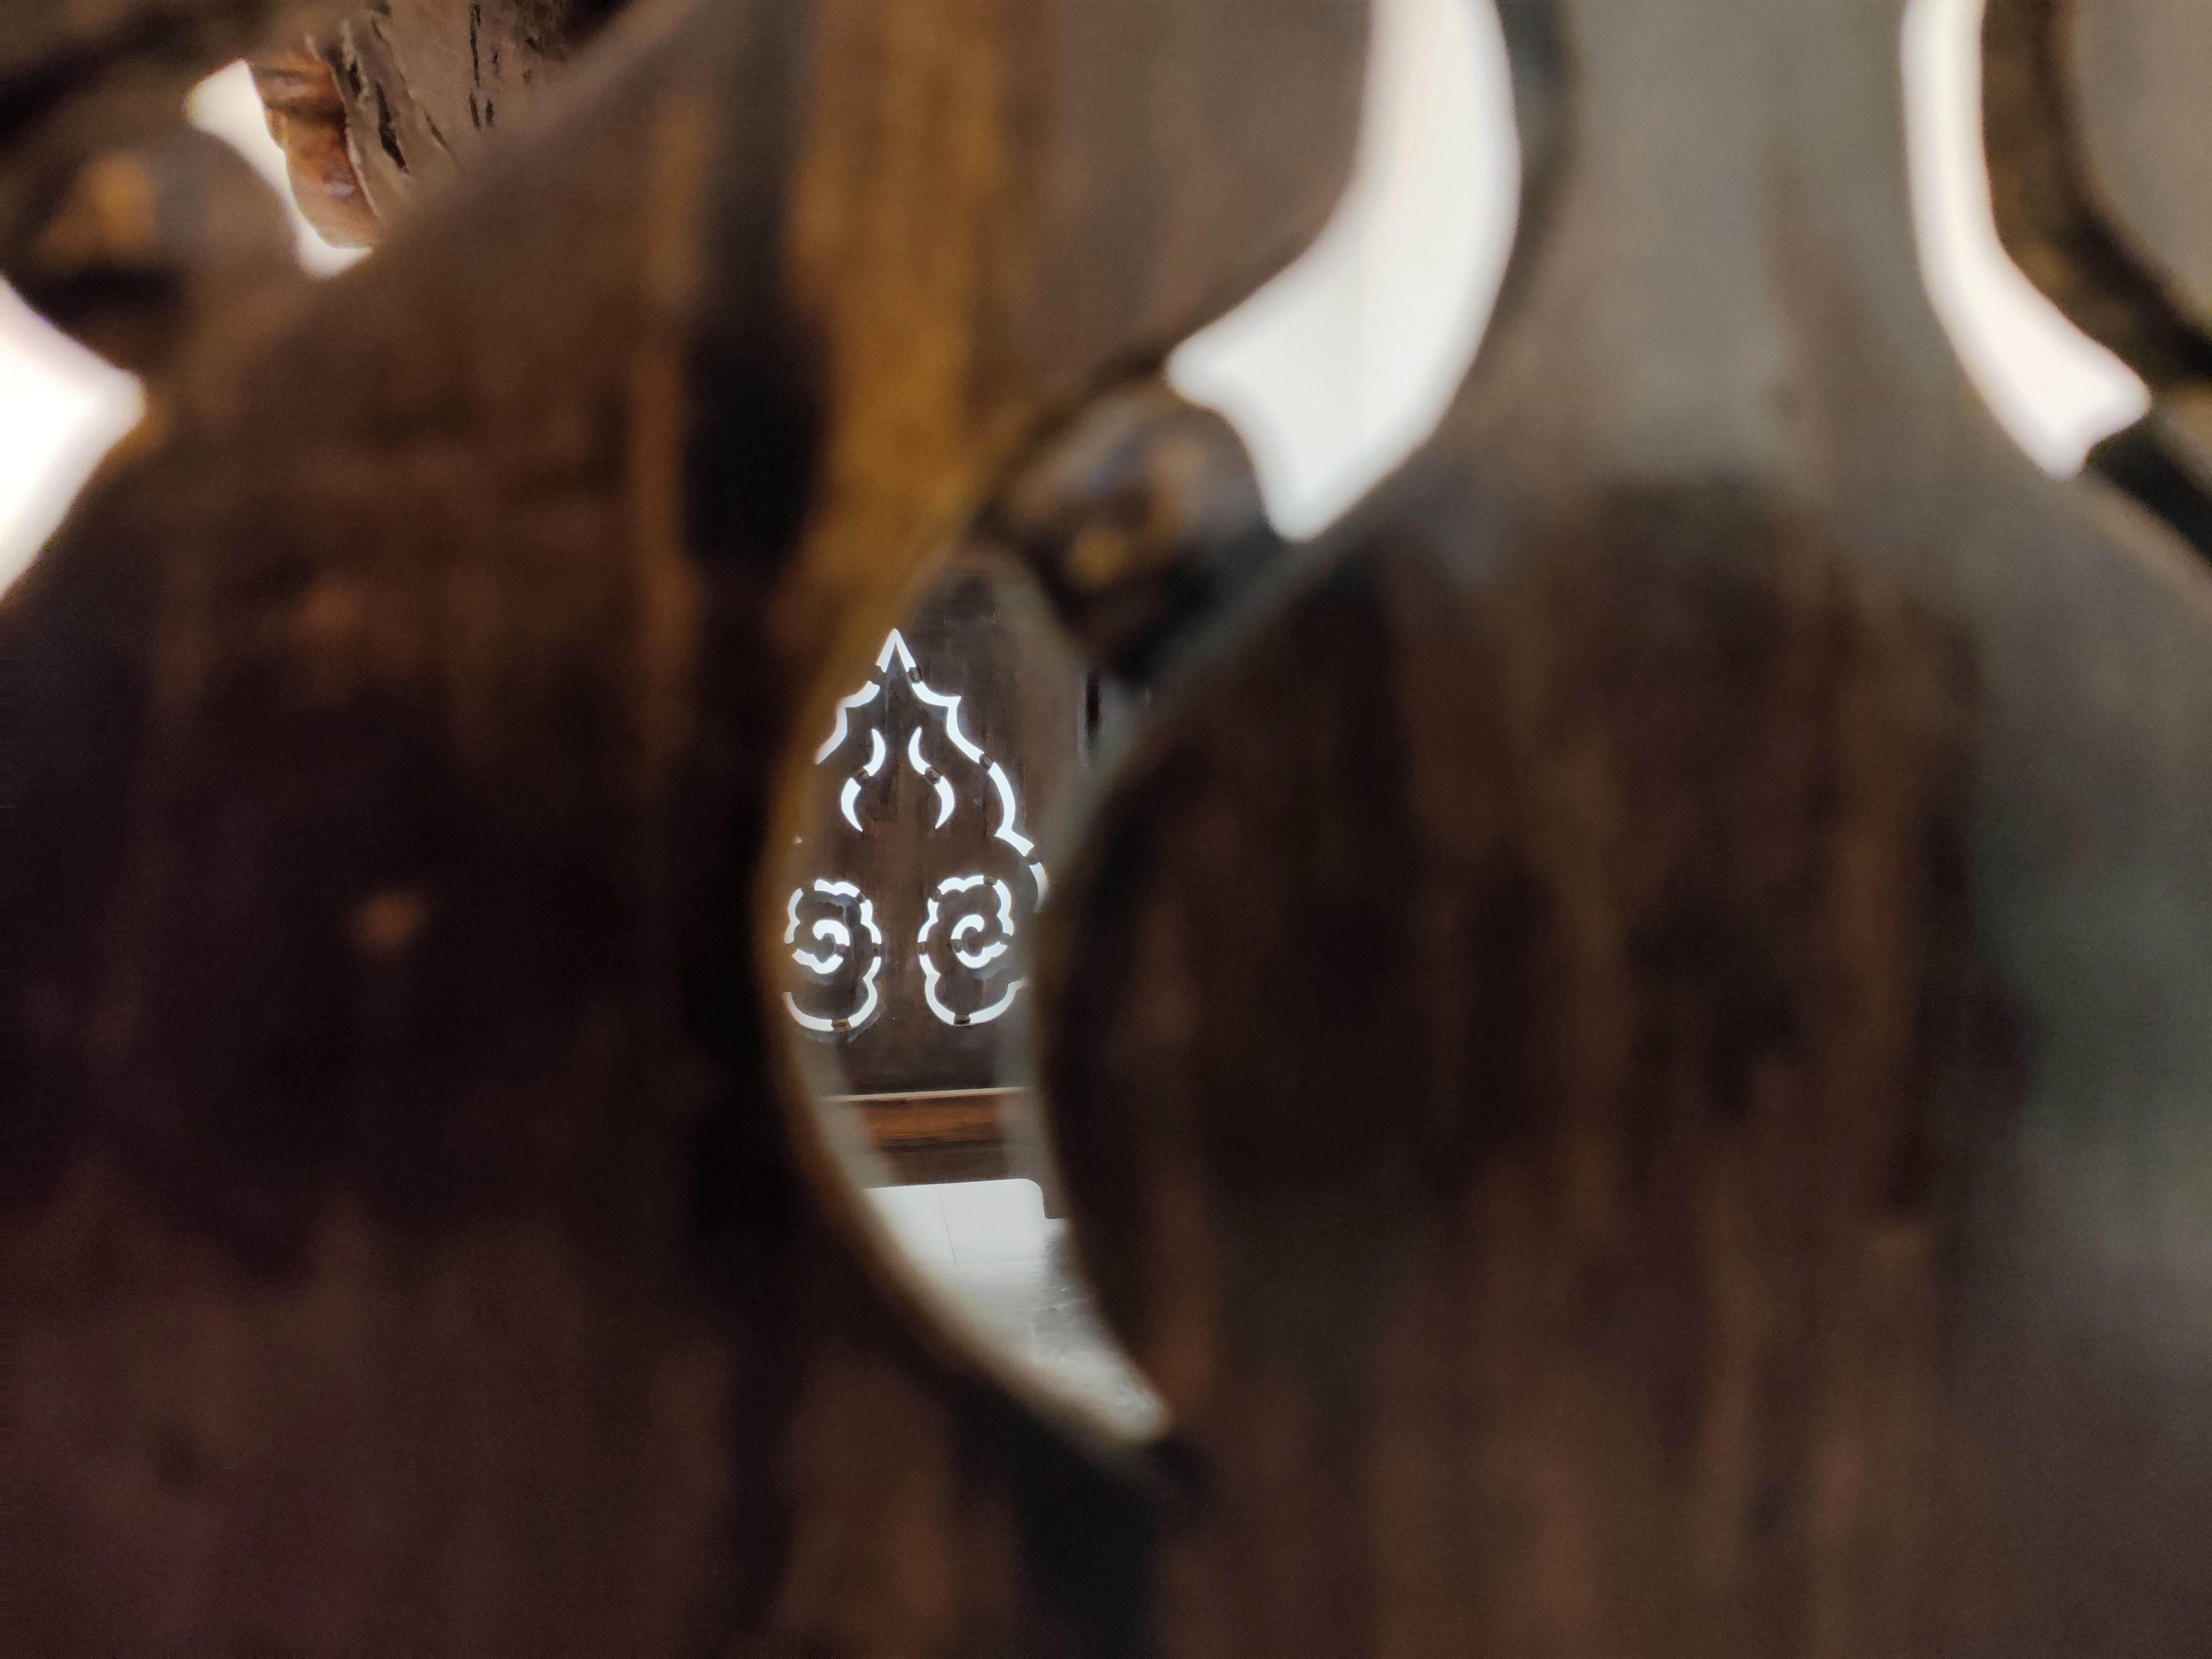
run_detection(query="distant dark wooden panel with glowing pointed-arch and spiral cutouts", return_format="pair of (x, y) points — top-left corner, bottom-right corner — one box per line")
(783, 566), (1086, 1095)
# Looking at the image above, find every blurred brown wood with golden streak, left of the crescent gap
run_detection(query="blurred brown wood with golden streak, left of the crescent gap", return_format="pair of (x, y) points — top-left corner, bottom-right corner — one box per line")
(0, 0), (1365, 1657)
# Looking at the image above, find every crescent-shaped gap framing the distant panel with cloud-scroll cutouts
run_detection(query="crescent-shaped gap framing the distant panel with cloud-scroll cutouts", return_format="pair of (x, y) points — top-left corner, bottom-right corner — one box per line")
(768, 551), (1161, 1440)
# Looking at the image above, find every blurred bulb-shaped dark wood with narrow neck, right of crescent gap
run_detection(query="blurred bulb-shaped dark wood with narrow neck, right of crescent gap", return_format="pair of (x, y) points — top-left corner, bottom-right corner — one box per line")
(1040, 0), (2212, 1659)
